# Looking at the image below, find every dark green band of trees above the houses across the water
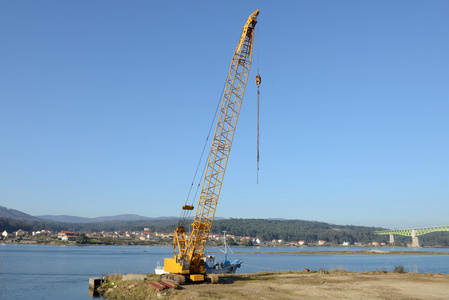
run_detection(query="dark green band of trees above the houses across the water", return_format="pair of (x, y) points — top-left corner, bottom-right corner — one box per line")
(0, 218), (449, 247)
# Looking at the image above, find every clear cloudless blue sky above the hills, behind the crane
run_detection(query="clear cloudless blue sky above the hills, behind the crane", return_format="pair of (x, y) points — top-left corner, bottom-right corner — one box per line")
(0, 0), (449, 228)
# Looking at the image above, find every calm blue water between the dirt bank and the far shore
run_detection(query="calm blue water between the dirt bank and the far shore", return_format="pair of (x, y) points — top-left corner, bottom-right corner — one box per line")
(0, 244), (449, 300)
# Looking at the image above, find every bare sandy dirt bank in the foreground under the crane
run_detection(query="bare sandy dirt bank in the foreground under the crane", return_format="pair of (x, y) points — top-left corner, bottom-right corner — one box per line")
(99, 271), (449, 299)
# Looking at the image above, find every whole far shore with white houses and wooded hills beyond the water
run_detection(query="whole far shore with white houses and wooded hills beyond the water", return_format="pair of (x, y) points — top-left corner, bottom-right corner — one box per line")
(0, 206), (449, 247)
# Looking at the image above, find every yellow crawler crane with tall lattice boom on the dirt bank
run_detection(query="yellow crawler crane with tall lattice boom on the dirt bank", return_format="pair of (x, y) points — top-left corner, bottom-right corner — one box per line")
(162, 10), (259, 284)
